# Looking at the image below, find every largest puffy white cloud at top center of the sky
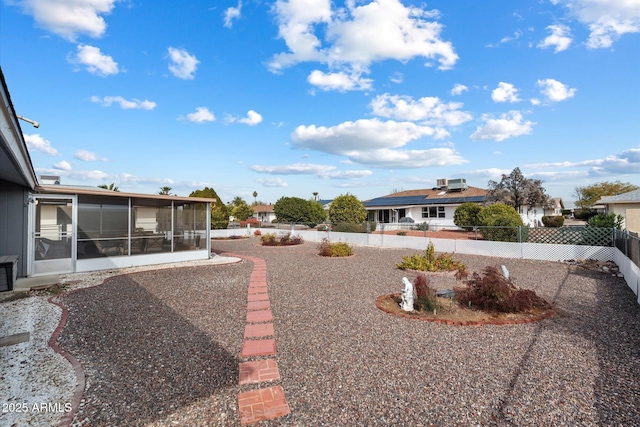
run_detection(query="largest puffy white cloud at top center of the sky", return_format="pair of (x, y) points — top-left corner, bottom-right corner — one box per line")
(269, 0), (458, 82)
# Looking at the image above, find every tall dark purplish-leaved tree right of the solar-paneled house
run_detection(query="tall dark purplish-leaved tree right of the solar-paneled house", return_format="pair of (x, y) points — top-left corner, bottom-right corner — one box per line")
(486, 168), (550, 212)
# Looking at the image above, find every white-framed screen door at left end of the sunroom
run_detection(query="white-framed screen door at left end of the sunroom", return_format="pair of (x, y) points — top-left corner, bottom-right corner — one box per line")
(29, 196), (76, 276)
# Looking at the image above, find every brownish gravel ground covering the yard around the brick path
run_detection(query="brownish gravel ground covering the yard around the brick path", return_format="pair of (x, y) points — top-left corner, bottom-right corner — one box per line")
(59, 238), (640, 426)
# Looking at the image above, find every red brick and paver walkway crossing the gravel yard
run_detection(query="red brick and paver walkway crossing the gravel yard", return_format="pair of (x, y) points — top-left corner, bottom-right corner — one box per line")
(229, 254), (291, 425)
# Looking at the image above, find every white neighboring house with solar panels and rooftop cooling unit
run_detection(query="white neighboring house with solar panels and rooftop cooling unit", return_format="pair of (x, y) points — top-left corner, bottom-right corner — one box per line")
(363, 179), (487, 229)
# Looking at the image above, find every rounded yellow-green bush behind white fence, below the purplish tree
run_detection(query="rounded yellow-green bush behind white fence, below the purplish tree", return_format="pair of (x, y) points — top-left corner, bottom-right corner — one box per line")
(478, 203), (527, 242)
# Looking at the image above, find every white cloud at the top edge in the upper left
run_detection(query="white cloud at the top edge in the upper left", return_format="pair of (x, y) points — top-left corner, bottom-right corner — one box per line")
(9, 0), (117, 42)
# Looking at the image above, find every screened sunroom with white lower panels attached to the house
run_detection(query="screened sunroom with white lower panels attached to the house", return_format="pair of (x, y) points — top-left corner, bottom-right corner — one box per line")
(27, 185), (215, 276)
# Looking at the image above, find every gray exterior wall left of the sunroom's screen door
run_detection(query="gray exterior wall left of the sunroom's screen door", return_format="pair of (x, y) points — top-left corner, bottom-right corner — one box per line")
(0, 180), (28, 277)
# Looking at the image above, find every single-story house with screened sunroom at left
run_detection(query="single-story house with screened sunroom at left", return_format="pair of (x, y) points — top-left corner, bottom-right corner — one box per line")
(0, 69), (215, 290)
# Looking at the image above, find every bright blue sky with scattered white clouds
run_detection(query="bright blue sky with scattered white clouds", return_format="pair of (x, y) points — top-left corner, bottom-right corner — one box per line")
(0, 0), (640, 206)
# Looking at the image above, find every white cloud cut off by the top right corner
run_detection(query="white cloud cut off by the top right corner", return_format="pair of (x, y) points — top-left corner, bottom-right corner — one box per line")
(556, 0), (640, 49)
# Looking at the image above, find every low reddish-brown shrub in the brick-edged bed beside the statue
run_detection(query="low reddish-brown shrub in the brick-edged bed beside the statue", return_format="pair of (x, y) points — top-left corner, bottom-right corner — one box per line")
(454, 266), (548, 313)
